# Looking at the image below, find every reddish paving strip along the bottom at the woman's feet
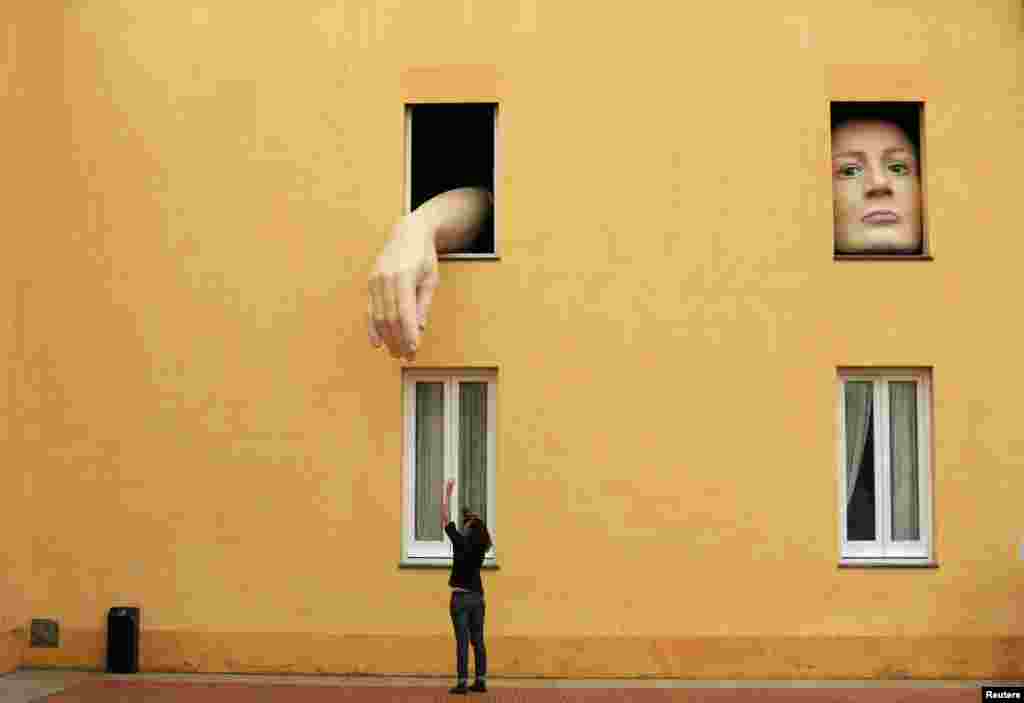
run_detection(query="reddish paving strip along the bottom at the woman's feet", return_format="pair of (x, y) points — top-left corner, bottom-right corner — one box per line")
(39, 679), (981, 703)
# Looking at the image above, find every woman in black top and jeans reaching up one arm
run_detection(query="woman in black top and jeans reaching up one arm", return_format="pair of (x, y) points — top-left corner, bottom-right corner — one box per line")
(441, 479), (492, 694)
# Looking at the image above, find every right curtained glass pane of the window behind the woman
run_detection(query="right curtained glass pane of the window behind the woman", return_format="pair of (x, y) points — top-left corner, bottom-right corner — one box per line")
(459, 383), (487, 522)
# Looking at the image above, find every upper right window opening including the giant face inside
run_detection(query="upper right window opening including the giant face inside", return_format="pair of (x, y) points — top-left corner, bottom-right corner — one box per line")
(829, 101), (929, 259)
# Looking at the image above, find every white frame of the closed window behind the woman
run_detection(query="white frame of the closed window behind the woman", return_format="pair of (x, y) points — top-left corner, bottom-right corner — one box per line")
(401, 368), (498, 566)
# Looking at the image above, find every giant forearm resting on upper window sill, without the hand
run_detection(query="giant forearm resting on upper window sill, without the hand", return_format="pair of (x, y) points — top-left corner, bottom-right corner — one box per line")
(402, 188), (494, 254)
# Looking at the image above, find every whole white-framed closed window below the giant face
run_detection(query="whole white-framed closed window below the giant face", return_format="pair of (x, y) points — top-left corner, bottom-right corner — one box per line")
(839, 369), (932, 564)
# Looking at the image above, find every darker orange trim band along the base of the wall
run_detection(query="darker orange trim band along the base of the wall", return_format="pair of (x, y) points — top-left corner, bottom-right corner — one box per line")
(16, 630), (1024, 679)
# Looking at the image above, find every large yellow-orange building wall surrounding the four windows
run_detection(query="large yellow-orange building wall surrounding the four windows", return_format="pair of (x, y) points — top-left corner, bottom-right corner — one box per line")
(8, 0), (1024, 678)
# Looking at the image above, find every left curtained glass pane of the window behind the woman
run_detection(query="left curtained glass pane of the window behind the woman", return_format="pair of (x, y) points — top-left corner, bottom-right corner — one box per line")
(415, 383), (444, 541)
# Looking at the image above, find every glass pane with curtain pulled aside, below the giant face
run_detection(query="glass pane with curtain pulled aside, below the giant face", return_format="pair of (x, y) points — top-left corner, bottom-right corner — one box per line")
(845, 381), (876, 541)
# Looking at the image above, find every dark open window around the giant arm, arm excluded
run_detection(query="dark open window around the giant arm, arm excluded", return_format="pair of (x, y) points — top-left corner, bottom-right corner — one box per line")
(406, 102), (498, 259)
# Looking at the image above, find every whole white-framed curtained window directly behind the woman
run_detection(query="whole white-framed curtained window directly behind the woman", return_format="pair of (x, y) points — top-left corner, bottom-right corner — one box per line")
(402, 368), (498, 565)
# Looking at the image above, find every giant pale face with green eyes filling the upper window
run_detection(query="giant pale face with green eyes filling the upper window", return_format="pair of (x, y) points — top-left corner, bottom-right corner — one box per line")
(831, 120), (923, 254)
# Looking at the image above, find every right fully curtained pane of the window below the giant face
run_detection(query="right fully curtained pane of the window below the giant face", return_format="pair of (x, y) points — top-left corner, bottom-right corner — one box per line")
(889, 381), (921, 540)
